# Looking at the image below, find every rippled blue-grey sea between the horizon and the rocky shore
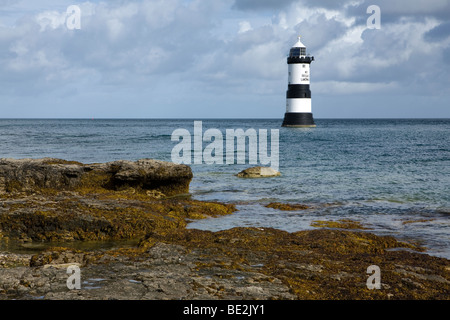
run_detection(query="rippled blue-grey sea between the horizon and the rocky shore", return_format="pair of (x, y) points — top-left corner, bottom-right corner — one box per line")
(0, 119), (450, 259)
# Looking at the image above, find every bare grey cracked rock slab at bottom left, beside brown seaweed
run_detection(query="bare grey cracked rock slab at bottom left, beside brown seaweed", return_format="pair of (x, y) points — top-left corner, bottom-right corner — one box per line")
(0, 243), (296, 300)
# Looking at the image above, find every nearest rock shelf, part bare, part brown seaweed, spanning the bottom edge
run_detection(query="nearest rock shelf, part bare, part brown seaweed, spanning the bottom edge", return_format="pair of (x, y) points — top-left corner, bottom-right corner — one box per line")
(0, 228), (450, 300)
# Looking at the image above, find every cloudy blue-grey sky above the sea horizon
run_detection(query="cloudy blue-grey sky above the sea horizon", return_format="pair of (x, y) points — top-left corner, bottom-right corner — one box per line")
(0, 0), (450, 119)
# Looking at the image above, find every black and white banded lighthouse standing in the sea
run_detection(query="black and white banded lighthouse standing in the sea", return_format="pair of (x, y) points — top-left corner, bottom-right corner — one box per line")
(282, 36), (316, 128)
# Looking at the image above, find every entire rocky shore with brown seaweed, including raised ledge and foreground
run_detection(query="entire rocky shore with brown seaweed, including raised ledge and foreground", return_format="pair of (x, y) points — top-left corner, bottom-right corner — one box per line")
(0, 158), (450, 300)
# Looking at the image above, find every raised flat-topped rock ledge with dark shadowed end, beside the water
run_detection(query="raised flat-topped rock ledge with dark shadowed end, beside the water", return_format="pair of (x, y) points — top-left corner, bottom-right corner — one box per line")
(0, 158), (193, 196)
